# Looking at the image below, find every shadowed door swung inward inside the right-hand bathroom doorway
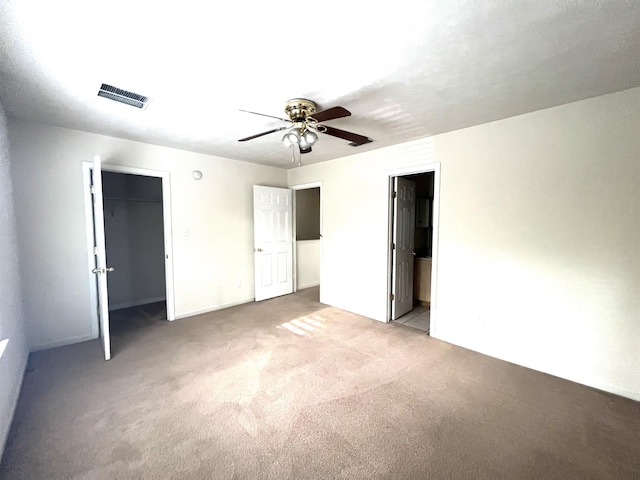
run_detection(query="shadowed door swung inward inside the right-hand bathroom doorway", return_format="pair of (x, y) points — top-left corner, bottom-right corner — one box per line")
(391, 177), (416, 320)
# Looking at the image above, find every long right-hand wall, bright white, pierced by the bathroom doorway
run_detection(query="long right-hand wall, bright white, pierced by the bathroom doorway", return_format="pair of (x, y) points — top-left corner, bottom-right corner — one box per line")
(288, 89), (640, 400)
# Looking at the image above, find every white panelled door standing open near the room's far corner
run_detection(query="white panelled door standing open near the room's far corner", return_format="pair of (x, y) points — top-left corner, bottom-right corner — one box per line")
(253, 185), (293, 301)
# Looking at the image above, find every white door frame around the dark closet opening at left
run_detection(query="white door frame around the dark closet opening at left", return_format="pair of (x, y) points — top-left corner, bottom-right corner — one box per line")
(82, 162), (176, 338)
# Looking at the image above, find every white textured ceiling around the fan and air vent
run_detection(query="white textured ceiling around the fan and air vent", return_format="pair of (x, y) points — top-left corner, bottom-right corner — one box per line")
(0, 0), (640, 168)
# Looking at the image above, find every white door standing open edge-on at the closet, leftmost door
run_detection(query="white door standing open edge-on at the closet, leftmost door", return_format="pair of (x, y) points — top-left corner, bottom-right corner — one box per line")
(91, 155), (113, 360)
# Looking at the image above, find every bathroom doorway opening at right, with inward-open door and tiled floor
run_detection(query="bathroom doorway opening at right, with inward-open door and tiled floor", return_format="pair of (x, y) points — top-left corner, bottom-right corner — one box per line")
(388, 165), (439, 334)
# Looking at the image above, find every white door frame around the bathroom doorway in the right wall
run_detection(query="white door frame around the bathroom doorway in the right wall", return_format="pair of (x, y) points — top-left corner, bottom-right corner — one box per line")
(386, 163), (440, 336)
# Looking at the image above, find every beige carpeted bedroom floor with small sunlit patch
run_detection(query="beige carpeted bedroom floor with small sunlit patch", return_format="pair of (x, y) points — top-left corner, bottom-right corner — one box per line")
(0, 289), (640, 480)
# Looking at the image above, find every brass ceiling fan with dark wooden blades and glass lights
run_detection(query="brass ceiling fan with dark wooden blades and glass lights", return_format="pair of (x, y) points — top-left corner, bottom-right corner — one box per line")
(238, 98), (373, 153)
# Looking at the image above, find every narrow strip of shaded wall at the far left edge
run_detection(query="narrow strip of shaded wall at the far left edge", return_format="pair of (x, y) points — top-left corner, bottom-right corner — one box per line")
(0, 101), (29, 459)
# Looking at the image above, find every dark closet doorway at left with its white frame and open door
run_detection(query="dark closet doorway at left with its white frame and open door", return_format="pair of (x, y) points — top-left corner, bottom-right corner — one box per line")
(83, 162), (175, 359)
